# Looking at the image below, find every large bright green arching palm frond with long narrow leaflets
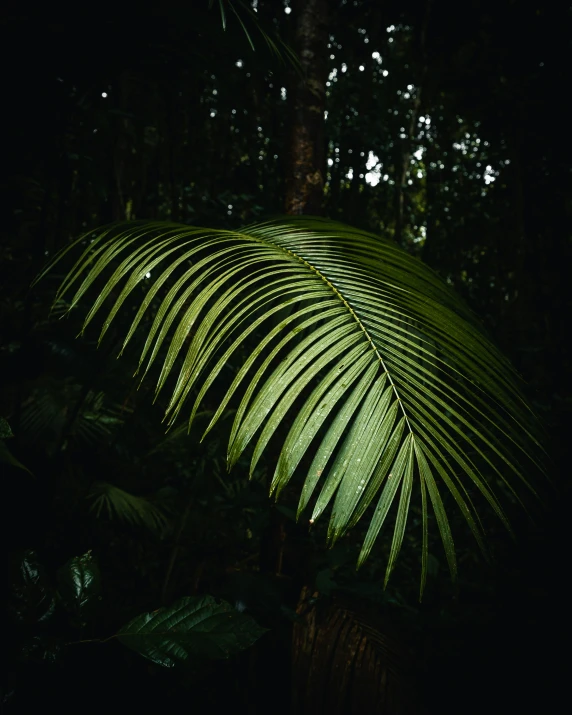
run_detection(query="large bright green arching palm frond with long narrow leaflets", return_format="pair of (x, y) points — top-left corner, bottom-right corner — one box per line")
(38, 217), (543, 600)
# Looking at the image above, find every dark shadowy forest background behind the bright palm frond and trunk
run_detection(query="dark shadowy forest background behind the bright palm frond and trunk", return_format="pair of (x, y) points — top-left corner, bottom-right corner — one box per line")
(0, 0), (572, 714)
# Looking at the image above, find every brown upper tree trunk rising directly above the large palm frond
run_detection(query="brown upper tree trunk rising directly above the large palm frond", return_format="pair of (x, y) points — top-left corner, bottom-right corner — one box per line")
(285, 0), (328, 214)
